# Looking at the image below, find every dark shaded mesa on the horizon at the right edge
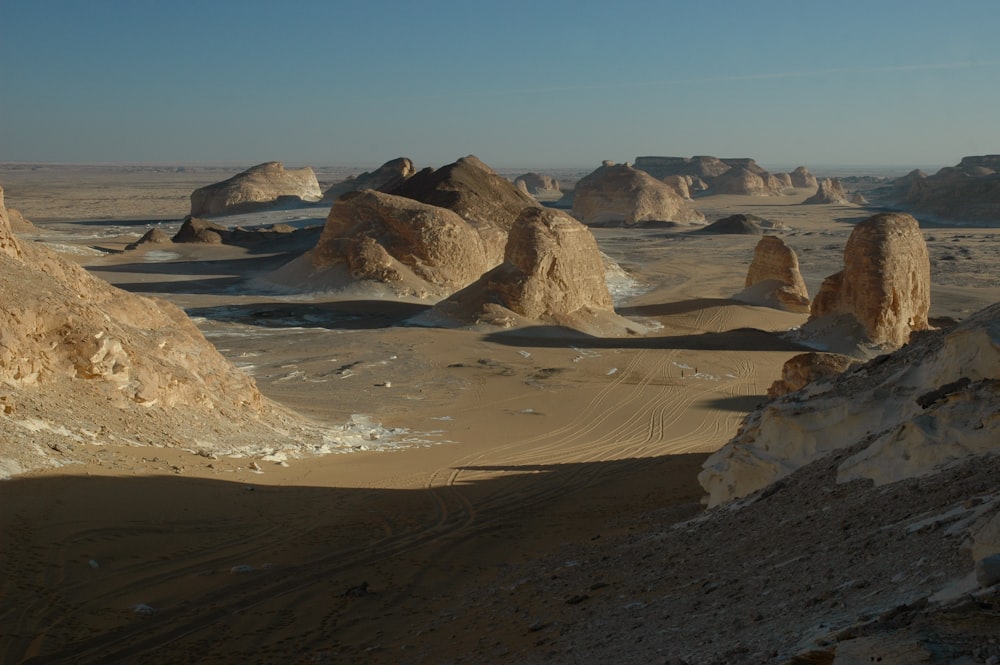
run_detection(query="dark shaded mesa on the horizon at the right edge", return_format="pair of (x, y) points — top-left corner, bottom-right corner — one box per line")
(894, 155), (1000, 221)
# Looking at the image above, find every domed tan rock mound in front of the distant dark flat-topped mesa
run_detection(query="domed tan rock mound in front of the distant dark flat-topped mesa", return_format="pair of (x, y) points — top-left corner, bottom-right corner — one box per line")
(573, 162), (705, 226)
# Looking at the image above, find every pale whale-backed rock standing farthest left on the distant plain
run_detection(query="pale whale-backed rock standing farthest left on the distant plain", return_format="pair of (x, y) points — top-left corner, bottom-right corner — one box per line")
(191, 162), (323, 217)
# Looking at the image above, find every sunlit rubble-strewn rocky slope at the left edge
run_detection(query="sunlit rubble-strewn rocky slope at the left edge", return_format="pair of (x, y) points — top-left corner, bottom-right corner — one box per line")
(0, 187), (328, 477)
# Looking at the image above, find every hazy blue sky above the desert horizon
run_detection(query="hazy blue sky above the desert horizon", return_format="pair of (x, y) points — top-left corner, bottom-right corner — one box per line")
(0, 0), (1000, 168)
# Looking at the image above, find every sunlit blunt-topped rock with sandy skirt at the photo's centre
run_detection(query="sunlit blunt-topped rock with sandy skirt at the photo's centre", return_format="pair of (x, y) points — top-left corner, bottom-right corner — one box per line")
(425, 208), (640, 334)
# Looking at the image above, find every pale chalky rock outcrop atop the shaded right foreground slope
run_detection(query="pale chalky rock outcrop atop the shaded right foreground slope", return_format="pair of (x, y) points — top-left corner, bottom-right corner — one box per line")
(698, 304), (1000, 506)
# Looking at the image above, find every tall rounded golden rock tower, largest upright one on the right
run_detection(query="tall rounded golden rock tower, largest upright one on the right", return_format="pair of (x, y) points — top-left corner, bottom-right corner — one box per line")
(802, 213), (931, 352)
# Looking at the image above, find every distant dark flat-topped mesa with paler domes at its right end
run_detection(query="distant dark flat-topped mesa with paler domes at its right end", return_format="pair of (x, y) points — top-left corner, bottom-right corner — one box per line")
(635, 155), (804, 196)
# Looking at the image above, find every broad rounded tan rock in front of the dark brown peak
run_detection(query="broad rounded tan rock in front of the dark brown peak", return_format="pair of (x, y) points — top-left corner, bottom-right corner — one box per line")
(269, 190), (497, 297)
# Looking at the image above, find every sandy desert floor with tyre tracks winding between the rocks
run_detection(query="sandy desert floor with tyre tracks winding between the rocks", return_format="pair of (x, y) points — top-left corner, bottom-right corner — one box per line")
(0, 166), (1000, 663)
